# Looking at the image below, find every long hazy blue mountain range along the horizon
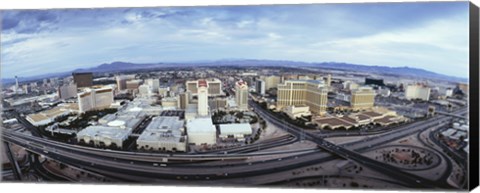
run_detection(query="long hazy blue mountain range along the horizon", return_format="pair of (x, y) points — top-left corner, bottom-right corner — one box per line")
(2, 59), (468, 84)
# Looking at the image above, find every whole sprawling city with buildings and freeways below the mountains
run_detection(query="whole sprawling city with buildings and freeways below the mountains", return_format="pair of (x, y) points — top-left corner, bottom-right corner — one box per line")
(2, 66), (469, 189)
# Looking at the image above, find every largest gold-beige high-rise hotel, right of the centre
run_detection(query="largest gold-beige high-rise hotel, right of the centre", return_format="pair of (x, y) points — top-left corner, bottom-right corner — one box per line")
(277, 80), (328, 114)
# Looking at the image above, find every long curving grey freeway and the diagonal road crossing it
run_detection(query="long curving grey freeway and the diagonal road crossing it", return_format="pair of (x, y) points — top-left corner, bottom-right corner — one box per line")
(2, 101), (467, 189)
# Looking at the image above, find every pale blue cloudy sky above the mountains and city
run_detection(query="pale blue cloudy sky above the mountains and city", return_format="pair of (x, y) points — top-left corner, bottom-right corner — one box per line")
(1, 2), (468, 78)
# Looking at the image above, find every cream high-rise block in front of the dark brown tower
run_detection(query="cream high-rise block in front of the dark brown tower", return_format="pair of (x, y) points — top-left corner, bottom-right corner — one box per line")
(77, 87), (113, 113)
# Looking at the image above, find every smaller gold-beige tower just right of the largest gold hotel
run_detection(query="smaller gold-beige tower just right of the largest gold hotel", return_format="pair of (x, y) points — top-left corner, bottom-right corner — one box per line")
(350, 87), (376, 110)
